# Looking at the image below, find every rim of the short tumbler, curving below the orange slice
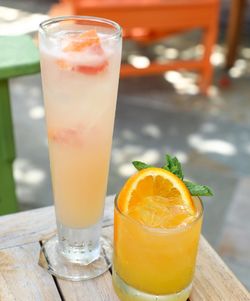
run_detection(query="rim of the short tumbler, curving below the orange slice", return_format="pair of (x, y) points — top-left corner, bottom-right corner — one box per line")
(114, 194), (204, 234)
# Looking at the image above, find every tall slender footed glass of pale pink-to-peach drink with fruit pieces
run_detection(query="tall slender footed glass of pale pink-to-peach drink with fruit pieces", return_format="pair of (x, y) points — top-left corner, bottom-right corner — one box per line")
(39, 16), (122, 280)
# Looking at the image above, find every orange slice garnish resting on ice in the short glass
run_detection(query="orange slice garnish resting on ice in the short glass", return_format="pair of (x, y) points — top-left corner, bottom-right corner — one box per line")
(117, 167), (196, 228)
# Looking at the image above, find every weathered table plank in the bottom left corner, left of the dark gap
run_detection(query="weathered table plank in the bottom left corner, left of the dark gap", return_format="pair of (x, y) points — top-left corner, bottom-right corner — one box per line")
(0, 242), (61, 301)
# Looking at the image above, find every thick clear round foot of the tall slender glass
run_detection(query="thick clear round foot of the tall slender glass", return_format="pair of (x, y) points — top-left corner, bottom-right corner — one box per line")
(40, 235), (112, 281)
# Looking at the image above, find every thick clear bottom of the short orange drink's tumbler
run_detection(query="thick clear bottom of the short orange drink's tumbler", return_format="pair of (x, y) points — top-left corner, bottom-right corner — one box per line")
(113, 269), (192, 301)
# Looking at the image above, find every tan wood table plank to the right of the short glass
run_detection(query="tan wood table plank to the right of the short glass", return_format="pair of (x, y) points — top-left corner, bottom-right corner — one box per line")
(190, 237), (250, 301)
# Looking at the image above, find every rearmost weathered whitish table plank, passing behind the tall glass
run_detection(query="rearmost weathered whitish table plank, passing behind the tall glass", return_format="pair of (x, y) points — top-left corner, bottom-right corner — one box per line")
(0, 196), (114, 250)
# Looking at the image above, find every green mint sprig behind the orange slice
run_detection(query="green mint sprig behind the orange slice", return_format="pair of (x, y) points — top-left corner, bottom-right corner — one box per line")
(132, 154), (213, 196)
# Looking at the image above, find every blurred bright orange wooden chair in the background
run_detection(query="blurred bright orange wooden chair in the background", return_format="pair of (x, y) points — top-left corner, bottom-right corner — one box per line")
(50, 0), (219, 93)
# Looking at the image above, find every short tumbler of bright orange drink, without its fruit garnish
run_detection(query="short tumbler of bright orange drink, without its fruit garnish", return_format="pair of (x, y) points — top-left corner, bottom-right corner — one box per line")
(113, 197), (203, 301)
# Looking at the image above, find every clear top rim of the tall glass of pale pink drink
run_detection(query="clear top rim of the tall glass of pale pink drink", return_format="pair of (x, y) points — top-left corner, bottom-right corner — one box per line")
(39, 15), (122, 40)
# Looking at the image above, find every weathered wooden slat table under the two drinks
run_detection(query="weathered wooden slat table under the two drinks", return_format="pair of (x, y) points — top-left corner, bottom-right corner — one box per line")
(0, 197), (250, 301)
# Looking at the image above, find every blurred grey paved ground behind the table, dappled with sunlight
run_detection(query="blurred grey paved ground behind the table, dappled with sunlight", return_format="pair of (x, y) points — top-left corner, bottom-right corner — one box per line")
(0, 0), (250, 288)
